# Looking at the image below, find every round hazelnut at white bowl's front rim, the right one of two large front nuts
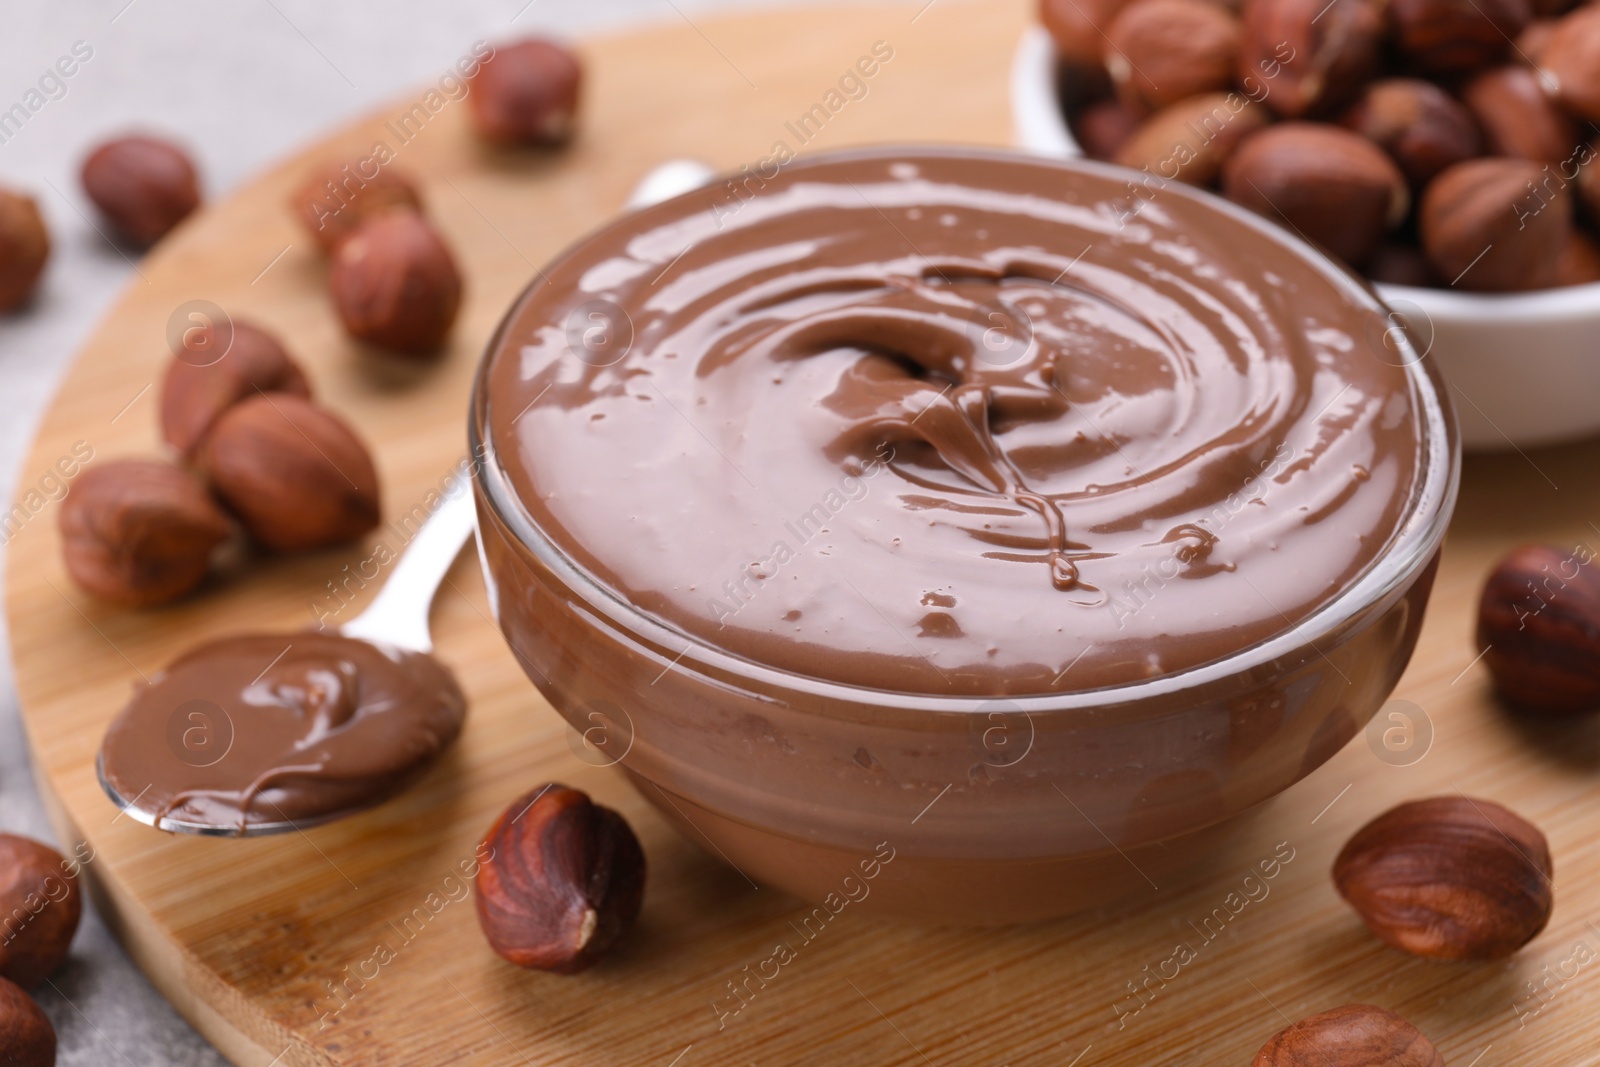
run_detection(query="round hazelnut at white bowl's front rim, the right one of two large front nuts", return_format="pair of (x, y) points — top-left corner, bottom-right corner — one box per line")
(1419, 158), (1573, 293)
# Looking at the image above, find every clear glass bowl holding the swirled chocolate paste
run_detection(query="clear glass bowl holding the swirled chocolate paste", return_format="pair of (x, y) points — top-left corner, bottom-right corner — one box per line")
(469, 149), (1461, 925)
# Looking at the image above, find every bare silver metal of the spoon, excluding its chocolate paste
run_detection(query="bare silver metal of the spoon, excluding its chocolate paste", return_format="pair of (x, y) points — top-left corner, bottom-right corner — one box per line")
(94, 160), (712, 837)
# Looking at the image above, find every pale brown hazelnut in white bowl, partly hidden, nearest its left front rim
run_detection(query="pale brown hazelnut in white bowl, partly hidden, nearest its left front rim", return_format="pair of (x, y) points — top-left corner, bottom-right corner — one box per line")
(1115, 93), (1269, 186)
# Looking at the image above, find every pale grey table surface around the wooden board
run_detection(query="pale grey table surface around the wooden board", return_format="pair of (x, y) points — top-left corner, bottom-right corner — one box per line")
(0, 0), (782, 1067)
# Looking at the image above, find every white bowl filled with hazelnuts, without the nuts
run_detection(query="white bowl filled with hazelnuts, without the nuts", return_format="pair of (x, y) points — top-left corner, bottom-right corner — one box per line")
(1011, 27), (1600, 451)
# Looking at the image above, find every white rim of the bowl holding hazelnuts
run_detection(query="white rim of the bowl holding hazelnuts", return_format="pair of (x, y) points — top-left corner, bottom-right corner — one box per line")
(1011, 26), (1600, 316)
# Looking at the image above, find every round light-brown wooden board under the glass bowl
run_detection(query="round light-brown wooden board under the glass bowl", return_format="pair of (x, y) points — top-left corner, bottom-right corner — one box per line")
(6, 0), (1600, 1067)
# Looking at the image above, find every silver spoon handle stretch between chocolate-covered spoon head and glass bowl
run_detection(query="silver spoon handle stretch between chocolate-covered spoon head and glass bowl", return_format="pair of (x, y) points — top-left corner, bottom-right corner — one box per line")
(339, 486), (477, 653)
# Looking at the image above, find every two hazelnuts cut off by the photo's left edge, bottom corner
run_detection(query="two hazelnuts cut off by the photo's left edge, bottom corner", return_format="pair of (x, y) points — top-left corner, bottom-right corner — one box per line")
(0, 833), (83, 1067)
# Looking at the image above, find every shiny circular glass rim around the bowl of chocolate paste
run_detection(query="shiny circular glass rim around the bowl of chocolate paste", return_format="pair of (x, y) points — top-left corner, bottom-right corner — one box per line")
(467, 144), (1461, 715)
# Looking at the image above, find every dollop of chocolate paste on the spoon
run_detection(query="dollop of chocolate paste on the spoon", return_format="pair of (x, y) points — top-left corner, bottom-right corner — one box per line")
(101, 632), (467, 829)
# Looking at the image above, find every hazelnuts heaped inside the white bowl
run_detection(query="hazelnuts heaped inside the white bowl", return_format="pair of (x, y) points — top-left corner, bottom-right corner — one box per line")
(1040, 0), (1600, 293)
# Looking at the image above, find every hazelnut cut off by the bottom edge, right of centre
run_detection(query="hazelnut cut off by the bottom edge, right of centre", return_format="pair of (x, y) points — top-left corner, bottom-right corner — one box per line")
(1250, 1005), (1445, 1067)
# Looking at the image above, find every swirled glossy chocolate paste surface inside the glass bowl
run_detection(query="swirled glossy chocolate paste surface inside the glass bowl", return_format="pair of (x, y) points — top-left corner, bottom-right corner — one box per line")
(485, 150), (1421, 694)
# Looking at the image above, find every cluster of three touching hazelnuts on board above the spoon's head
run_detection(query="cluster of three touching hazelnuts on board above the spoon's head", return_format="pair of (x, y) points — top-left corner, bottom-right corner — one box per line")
(61, 322), (379, 608)
